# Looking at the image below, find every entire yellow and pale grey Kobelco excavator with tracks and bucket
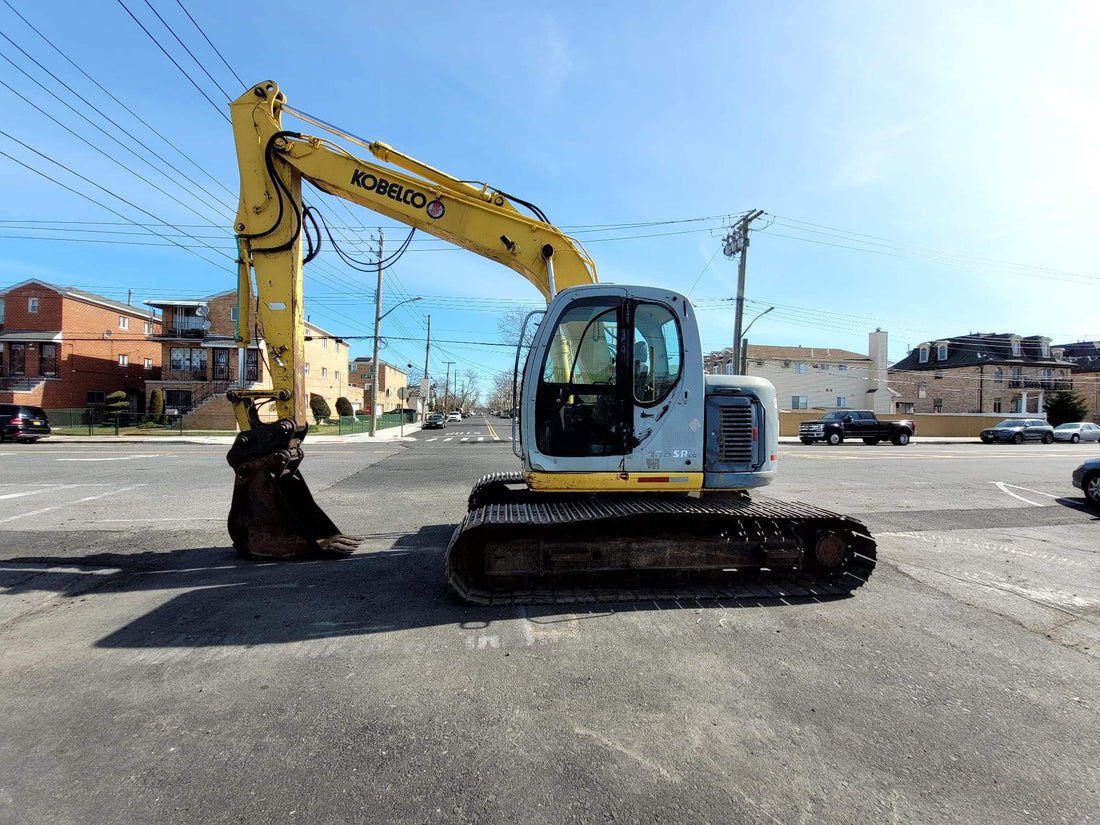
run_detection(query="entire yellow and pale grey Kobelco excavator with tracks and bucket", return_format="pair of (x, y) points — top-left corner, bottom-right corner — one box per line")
(228, 81), (876, 604)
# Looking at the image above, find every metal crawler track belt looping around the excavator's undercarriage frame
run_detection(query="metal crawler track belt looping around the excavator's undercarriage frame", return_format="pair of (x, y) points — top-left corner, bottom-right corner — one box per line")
(447, 484), (876, 605)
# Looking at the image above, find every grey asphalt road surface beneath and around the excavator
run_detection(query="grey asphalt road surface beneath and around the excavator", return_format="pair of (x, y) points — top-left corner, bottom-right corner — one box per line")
(0, 418), (1100, 824)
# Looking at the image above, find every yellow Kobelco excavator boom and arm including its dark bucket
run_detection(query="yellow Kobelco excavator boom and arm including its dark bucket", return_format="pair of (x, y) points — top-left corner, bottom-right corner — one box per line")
(228, 81), (596, 557)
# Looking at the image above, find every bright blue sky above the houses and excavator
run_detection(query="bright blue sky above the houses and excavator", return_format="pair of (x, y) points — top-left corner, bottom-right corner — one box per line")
(0, 0), (1100, 384)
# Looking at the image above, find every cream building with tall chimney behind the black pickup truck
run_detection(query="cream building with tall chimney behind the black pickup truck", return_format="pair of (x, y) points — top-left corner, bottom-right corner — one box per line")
(703, 330), (892, 413)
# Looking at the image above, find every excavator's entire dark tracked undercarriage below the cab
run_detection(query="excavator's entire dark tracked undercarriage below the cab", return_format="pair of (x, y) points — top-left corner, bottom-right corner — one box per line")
(447, 473), (876, 604)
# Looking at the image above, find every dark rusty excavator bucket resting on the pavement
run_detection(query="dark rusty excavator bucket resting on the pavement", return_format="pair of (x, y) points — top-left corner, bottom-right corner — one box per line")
(227, 419), (361, 559)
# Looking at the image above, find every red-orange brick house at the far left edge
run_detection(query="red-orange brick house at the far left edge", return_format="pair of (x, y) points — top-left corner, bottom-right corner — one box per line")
(0, 279), (161, 413)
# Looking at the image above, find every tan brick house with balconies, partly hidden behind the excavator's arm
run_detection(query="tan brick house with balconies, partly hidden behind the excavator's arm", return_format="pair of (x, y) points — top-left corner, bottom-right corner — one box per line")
(145, 289), (348, 429)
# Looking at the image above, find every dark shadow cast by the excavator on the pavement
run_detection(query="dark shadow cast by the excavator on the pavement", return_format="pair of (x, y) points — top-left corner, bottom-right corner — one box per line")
(0, 525), (871, 648)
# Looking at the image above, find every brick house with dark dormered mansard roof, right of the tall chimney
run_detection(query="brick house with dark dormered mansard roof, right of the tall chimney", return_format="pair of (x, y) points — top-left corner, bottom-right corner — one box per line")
(890, 332), (1073, 416)
